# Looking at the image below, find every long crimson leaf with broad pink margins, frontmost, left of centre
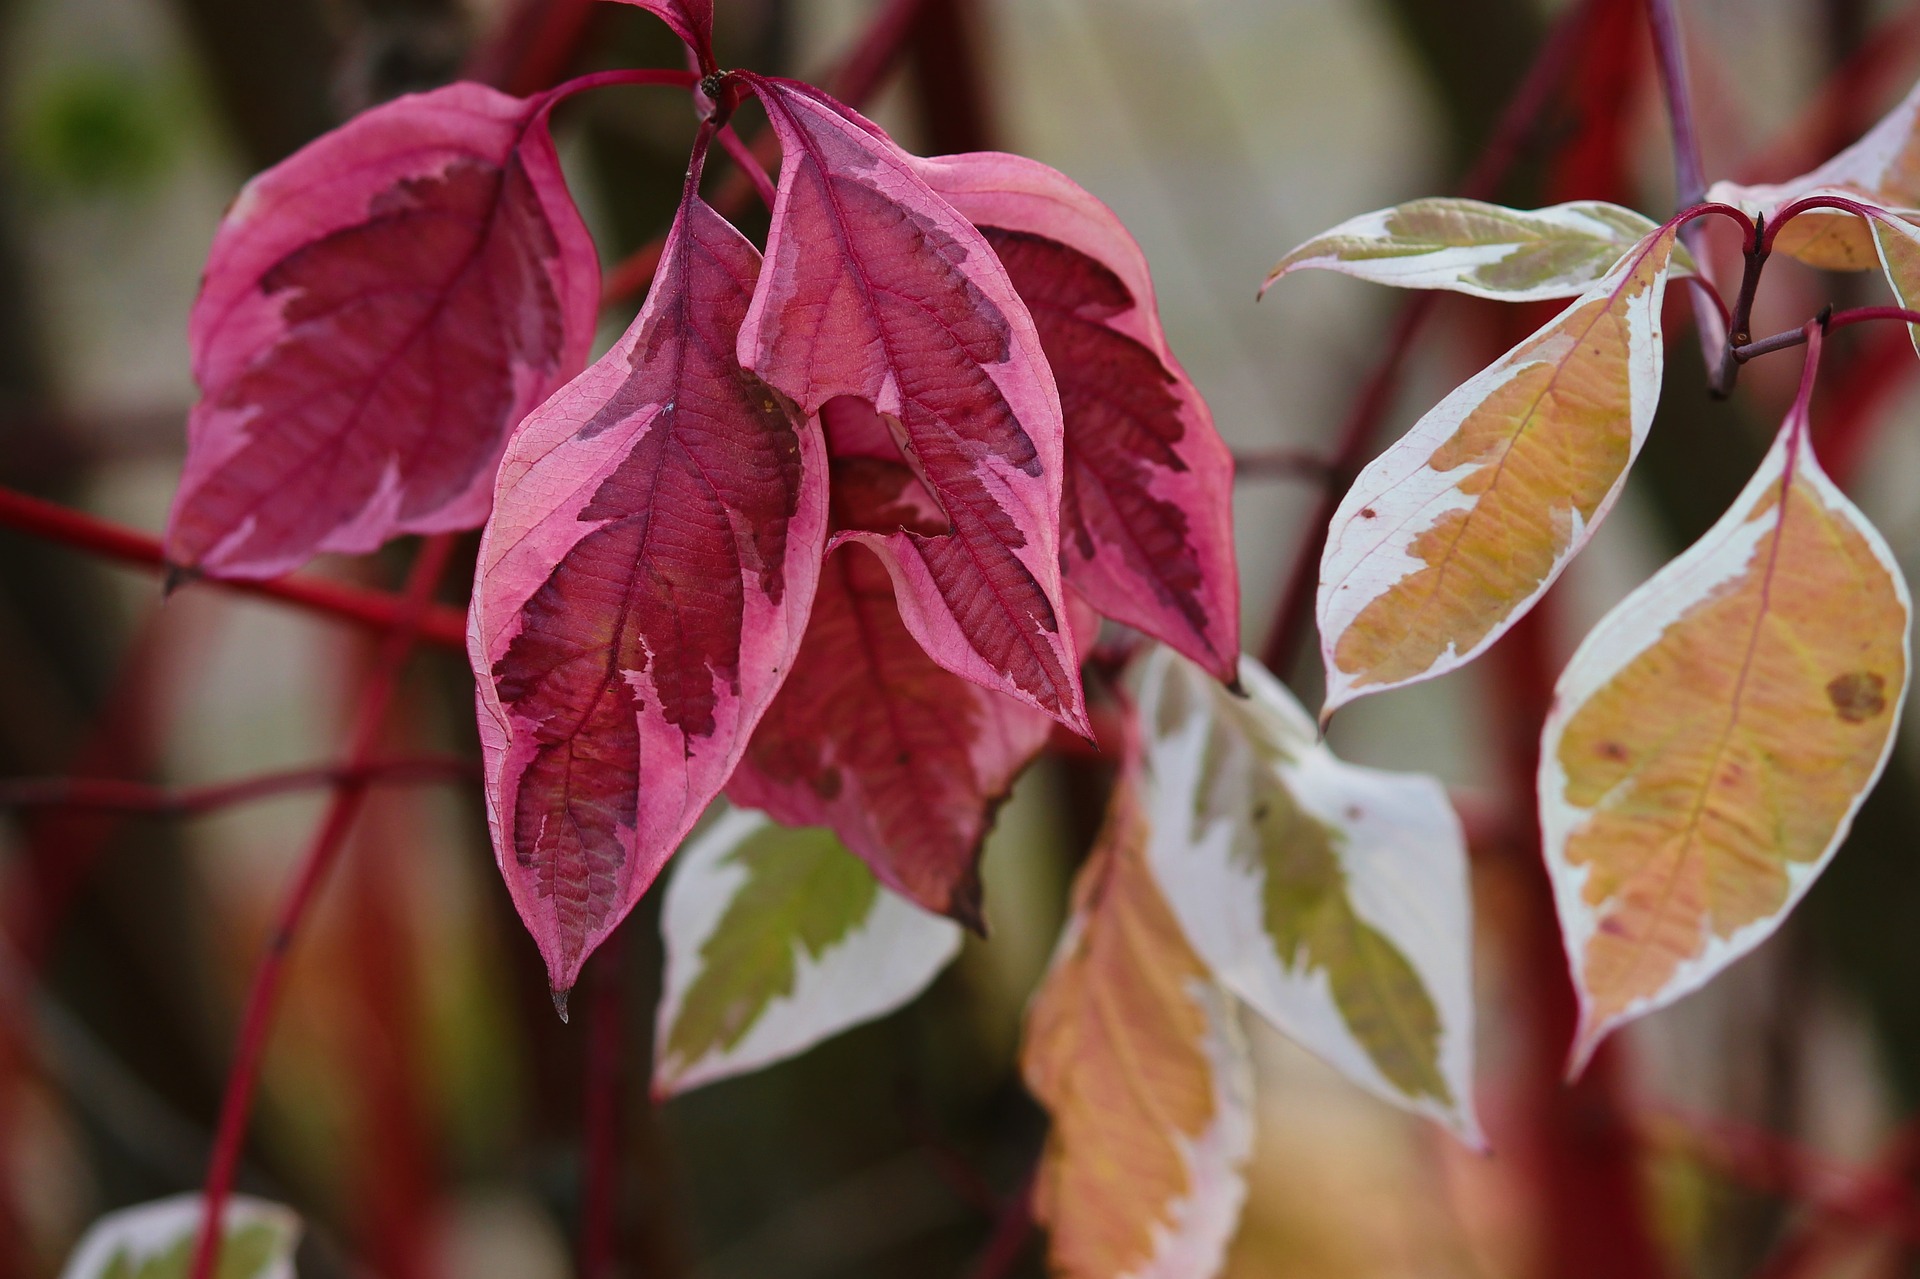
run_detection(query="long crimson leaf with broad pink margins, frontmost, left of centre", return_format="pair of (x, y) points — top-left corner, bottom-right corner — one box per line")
(468, 194), (826, 989)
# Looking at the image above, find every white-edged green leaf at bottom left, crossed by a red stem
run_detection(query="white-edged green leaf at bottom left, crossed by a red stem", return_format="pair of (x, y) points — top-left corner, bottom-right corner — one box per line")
(60, 1195), (300, 1279)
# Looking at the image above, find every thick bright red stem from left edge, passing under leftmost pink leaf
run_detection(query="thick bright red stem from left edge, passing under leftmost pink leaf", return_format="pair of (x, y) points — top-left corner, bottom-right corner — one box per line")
(0, 488), (467, 649)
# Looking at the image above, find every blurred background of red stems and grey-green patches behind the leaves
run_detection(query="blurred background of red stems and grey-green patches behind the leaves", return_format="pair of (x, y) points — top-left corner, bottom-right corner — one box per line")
(0, 0), (1920, 1279)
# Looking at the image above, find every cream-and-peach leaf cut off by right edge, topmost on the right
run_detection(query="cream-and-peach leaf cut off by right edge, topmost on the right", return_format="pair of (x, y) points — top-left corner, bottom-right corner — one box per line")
(1707, 75), (1920, 271)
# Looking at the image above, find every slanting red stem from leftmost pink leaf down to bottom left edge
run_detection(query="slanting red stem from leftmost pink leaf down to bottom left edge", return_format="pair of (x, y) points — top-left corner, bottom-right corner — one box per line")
(190, 534), (453, 1279)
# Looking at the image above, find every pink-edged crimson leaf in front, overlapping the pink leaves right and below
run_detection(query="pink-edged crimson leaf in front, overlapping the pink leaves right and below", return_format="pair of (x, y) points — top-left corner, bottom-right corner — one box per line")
(739, 77), (1087, 732)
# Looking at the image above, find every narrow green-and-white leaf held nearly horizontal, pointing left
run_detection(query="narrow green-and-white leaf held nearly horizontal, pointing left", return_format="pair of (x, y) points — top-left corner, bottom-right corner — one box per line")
(1261, 198), (1692, 302)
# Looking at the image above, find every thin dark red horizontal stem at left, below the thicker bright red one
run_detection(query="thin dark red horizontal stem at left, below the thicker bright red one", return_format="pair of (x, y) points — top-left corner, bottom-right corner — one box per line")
(0, 755), (480, 816)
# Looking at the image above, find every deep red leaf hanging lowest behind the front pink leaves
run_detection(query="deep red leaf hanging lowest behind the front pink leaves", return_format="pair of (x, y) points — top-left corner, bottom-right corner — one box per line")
(728, 412), (1096, 929)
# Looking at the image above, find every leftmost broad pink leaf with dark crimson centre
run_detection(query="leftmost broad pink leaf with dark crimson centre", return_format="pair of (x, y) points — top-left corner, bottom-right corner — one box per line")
(167, 84), (599, 578)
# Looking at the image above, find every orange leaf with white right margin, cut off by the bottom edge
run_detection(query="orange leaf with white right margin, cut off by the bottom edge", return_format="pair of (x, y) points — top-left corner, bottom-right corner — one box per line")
(1021, 764), (1254, 1279)
